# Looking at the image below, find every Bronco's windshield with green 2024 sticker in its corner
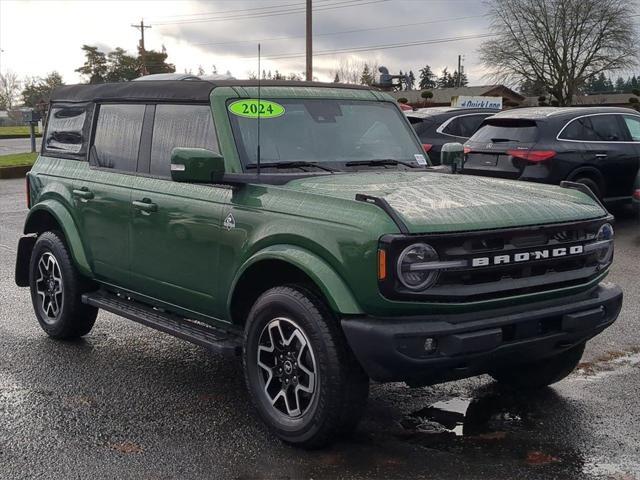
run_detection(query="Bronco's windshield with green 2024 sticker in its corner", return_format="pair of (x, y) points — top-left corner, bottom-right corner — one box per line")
(228, 99), (426, 168)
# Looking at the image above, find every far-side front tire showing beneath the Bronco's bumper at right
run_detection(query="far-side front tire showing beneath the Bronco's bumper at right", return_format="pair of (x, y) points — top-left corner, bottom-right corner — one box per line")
(491, 343), (585, 390)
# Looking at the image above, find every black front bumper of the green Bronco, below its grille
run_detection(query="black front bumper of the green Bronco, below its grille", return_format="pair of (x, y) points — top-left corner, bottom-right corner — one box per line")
(342, 282), (622, 385)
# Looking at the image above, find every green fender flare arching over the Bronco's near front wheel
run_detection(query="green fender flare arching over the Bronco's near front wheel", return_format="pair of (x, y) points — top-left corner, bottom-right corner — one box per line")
(227, 245), (364, 315)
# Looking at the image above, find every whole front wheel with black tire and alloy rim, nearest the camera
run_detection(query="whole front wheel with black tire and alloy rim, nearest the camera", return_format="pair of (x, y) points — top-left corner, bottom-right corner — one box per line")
(243, 287), (369, 448)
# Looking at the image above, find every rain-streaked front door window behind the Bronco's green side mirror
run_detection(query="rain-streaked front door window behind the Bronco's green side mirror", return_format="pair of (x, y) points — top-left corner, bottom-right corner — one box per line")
(150, 105), (219, 177)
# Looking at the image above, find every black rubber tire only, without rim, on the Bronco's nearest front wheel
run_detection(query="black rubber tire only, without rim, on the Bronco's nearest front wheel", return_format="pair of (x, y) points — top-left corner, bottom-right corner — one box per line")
(243, 286), (369, 448)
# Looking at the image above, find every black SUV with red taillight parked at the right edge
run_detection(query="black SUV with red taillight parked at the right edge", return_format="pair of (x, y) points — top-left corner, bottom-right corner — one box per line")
(462, 107), (640, 202)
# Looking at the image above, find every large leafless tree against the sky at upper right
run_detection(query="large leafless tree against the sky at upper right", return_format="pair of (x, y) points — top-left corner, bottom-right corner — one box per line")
(480, 0), (638, 106)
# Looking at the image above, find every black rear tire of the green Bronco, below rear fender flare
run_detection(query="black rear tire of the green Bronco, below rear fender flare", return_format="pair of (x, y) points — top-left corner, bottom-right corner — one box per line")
(29, 231), (98, 340)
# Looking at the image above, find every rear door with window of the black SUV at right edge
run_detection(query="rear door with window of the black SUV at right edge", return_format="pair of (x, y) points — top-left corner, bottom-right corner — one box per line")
(583, 114), (638, 200)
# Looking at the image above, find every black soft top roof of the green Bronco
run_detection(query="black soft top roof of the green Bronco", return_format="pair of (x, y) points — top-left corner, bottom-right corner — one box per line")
(51, 80), (368, 102)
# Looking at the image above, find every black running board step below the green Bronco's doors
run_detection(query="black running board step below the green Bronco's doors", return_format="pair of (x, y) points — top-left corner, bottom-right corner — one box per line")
(82, 290), (242, 356)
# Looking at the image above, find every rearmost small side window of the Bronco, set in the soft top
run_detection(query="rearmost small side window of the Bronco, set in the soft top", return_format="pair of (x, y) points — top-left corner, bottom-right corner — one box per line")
(44, 105), (90, 156)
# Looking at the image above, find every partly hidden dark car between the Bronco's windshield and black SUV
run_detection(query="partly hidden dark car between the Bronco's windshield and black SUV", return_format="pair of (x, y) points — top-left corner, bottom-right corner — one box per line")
(405, 107), (500, 165)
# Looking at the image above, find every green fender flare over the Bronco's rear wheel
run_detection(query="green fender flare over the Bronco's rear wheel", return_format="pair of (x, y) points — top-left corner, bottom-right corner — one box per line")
(24, 199), (92, 277)
